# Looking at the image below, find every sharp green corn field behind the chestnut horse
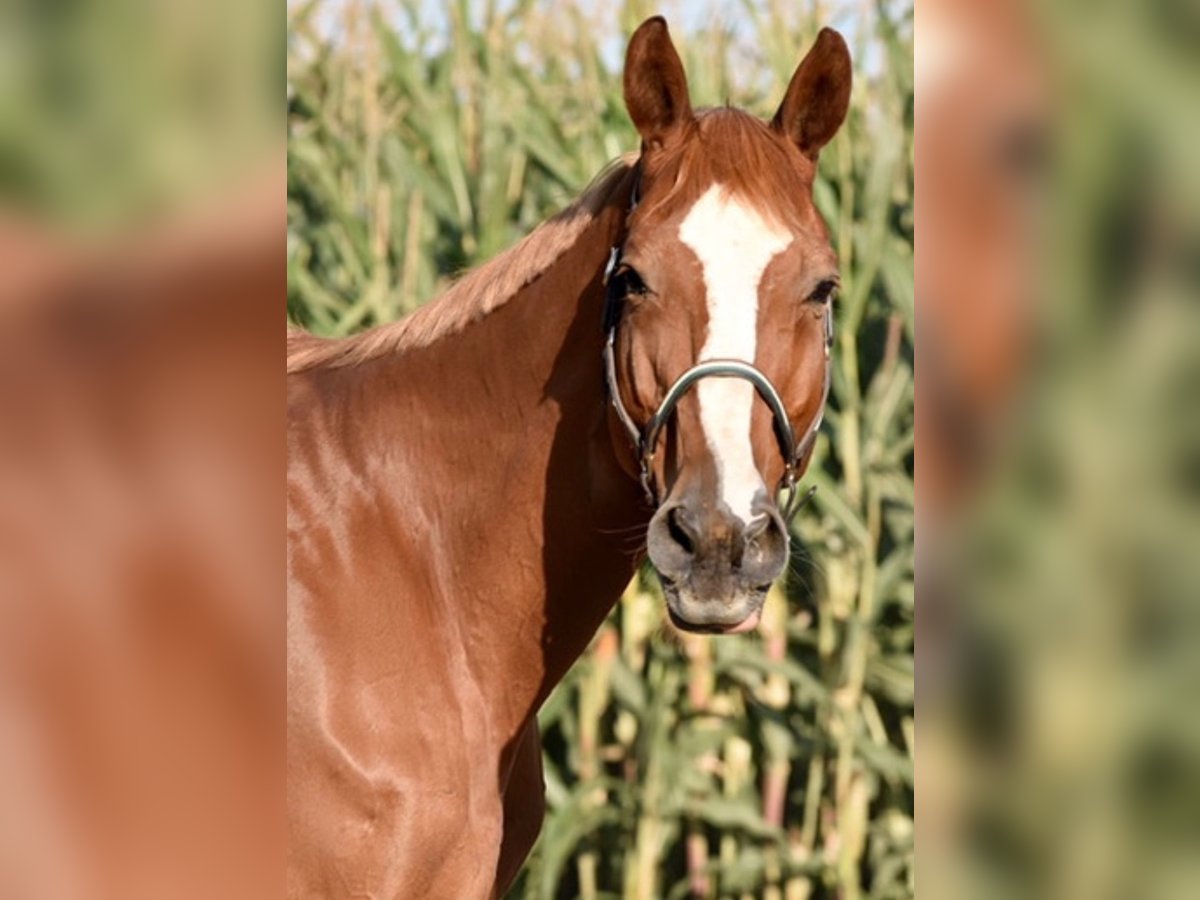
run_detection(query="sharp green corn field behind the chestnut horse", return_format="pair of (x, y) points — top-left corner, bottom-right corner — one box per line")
(287, 0), (914, 900)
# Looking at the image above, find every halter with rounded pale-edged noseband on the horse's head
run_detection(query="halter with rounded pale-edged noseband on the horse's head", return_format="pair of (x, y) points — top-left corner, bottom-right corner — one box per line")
(604, 166), (833, 523)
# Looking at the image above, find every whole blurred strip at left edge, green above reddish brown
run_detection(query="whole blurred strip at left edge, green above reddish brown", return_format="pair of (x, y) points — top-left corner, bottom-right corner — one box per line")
(0, 0), (286, 900)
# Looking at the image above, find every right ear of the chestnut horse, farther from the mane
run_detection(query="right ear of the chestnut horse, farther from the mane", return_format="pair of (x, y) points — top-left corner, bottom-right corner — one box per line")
(772, 28), (851, 162)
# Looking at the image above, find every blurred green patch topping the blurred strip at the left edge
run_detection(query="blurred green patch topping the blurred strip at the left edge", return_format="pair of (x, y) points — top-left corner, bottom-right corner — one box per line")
(0, 0), (276, 229)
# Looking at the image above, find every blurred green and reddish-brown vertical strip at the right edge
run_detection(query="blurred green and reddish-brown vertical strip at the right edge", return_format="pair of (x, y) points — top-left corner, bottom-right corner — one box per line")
(916, 0), (1200, 900)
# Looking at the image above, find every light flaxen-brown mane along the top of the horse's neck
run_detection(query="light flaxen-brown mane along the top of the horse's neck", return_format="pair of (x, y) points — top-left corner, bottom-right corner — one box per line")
(287, 154), (637, 374)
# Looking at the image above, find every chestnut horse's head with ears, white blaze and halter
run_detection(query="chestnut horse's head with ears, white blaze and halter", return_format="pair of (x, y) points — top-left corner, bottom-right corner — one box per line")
(607, 18), (851, 632)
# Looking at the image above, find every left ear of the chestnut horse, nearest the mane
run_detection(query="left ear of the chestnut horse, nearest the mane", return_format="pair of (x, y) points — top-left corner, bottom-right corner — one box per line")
(625, 16), (692, 148)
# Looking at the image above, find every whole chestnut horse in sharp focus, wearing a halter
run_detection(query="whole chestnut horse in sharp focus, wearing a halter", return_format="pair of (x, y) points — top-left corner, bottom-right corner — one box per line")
(287, 17), (851, 899)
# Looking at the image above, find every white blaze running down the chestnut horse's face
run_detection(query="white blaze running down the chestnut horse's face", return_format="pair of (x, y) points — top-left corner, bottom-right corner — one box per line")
(679, 185), (792, 522)
